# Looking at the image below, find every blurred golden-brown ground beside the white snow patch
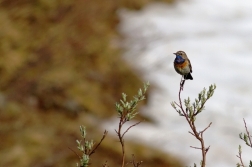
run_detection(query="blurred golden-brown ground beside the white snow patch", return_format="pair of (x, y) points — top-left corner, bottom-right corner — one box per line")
(0, 0), (181, 167)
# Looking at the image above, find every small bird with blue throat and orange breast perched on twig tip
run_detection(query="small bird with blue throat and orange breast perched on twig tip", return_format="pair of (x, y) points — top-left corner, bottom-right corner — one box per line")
(174, 51), (193, 80)
